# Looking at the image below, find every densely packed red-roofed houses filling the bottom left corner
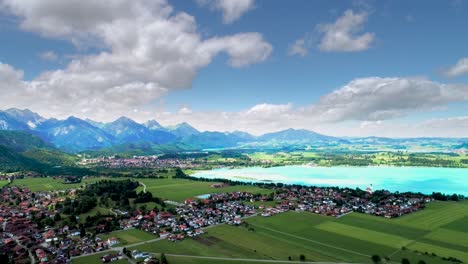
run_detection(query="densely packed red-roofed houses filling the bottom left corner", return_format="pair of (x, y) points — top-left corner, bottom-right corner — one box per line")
(0, 186), (120, 264)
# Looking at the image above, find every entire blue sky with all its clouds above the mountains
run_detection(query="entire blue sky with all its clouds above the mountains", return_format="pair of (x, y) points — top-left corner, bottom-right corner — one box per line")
(0, 0), (468, 136)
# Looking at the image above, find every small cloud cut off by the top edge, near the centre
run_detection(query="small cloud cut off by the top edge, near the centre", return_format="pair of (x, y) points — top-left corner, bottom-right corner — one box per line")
(197, 0), (255, 24)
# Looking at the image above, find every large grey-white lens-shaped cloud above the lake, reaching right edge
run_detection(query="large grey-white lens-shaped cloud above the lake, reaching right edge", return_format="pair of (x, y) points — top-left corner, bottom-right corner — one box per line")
(309, 77), (468, 122)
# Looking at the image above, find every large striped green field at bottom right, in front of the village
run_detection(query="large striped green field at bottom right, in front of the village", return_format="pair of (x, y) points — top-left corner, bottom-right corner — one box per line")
(122, 202), (468, 264)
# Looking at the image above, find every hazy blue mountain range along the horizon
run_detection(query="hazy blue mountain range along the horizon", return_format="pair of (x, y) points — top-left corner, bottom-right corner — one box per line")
(0, 108), (466, 154)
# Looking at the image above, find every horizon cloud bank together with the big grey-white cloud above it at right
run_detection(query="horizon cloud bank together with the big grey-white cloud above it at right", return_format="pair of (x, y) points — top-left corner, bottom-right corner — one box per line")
(148, 77), (468, 137)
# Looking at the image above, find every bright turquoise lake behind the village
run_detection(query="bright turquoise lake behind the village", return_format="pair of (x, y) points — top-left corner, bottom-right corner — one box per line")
(191, 166), (468, 196)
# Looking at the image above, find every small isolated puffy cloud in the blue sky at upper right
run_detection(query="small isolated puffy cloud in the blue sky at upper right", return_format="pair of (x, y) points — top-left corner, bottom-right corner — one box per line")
(317, 10), (374, 52)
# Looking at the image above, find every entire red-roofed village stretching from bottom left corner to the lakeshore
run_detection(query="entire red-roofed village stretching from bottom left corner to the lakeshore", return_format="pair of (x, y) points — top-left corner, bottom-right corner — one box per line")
(0, 182), (432, 263)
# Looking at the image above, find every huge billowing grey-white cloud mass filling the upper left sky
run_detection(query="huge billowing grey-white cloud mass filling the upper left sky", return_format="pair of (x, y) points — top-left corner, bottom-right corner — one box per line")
(0, 0), (273, 120)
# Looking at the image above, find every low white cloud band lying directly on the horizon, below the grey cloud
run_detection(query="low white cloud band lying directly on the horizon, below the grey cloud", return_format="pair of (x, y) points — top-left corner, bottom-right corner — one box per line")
(126, 104), (468, 137)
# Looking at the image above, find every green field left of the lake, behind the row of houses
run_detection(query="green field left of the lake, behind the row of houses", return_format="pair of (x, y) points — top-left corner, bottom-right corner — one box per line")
(138, 179), (270, 202)
